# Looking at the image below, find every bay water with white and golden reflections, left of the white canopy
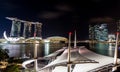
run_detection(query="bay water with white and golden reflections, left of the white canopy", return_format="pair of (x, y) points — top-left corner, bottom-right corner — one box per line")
(0, 43), (64, 58)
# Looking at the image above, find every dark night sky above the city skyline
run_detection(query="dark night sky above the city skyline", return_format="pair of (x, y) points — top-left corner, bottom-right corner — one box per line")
(0, 0), (120, 40)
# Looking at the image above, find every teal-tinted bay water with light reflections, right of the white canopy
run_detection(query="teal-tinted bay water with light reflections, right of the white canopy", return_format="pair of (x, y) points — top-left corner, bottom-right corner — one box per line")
(90, 43), (120, 58)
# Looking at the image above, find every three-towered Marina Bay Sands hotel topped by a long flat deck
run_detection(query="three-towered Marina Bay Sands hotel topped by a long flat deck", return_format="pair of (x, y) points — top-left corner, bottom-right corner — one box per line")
(6, 17), (42, 38)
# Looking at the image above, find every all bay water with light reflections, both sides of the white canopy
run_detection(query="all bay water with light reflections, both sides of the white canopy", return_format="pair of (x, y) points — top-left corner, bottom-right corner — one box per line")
(0, 43), (120, 57)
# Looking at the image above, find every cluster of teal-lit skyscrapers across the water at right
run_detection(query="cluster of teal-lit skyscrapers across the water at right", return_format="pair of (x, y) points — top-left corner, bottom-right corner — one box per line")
(89, 23), (108, 41)
